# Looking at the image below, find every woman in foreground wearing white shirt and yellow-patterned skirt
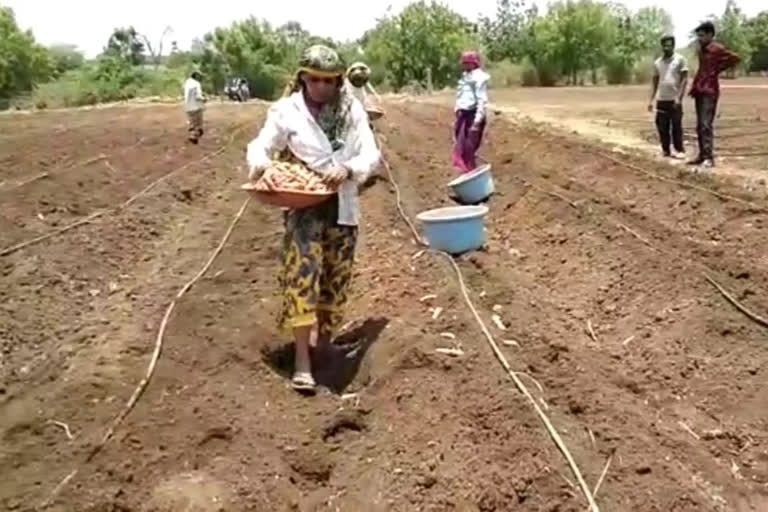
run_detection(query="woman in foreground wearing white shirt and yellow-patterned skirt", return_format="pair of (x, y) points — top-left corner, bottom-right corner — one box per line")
(247, 45), (380, 393)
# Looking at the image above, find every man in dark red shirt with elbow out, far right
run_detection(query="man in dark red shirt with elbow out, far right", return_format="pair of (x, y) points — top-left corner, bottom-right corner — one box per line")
(690, 21), (741, 167)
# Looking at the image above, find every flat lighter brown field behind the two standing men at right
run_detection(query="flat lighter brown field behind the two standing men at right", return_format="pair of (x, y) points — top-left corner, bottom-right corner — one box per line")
(493, 78), (768, 177)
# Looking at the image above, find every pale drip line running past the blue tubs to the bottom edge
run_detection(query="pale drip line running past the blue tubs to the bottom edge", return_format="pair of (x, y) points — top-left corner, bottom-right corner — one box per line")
(377, 137), (604, 512)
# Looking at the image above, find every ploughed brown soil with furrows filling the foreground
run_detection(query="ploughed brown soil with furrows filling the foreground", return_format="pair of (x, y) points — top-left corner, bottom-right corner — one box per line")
(0, 96), (768, 512)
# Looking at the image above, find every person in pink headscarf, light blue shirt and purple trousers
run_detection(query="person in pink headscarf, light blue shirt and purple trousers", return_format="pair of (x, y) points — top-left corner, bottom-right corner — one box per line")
(453, 52), (491, 173)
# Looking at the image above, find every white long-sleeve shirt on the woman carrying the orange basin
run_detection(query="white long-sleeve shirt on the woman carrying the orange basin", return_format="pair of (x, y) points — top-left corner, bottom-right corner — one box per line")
(246, 92), (381, 226)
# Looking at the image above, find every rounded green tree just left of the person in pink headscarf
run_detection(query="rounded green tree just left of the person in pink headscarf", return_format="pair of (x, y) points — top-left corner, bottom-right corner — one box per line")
(362, 0), (478, 89)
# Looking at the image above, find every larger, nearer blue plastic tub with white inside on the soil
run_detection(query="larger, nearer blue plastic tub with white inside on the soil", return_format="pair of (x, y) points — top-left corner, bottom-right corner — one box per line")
(416, 205), (488, 254)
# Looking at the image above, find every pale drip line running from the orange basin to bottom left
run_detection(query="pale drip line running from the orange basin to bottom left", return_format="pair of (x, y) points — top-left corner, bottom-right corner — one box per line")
(37, 193), (251, 510)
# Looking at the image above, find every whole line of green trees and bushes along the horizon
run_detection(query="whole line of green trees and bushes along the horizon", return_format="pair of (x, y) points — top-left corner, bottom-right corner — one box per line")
(0, 0), (768, 108)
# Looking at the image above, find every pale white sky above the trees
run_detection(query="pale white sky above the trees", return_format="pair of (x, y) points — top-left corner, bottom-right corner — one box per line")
(6, 0), (767, 57)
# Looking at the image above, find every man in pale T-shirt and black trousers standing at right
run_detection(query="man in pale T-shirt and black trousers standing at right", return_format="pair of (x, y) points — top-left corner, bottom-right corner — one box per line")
(648, 36), (688, 158)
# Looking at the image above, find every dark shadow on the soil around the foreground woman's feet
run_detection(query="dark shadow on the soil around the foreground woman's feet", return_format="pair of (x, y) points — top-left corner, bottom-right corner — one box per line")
(262, 317), (389, 394)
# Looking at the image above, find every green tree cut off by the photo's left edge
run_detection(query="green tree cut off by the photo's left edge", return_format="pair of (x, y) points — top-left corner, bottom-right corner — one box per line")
(0, 6), (53, 106)
